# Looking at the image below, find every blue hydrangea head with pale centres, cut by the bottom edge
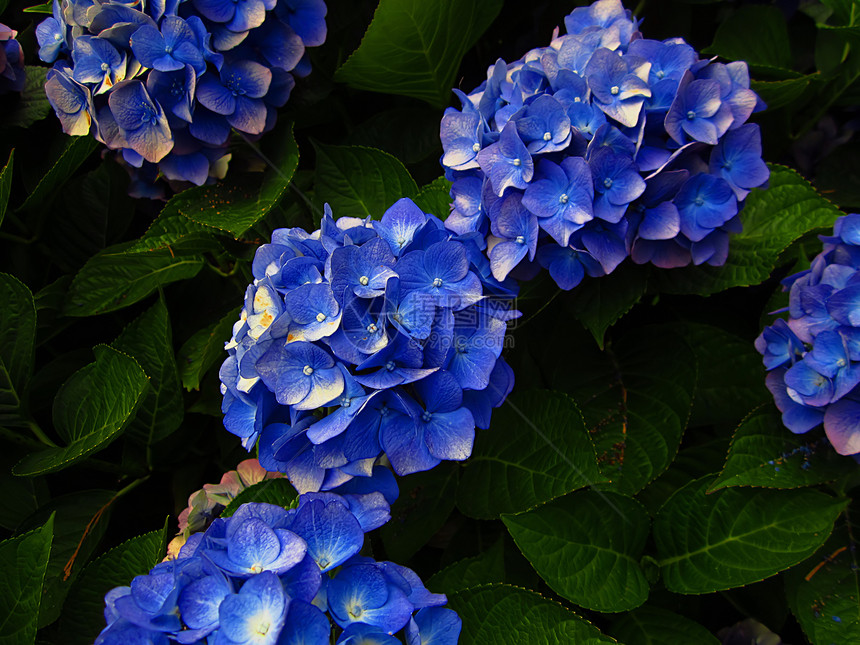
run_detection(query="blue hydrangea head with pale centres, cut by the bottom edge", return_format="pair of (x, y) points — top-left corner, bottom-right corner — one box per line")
(96, 492), (461, 645)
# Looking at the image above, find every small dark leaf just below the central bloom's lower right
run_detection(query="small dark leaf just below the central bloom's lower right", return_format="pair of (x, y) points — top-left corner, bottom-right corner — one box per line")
(379, 463), (460, 562)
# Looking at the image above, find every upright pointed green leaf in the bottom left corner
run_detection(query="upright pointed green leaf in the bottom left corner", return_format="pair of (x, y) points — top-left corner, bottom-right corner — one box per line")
(0, 510), (54, 645)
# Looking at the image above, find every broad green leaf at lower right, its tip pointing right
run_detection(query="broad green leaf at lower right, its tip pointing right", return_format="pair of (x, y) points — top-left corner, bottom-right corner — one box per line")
(654, 475), (847, 594)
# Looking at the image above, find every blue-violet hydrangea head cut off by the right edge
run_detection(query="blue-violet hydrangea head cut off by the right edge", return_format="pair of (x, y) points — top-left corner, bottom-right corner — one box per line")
(756, 214), (860, 458)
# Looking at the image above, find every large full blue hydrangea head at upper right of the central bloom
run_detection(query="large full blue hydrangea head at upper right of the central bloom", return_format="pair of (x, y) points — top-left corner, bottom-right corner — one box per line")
(441, 0), (769, 289)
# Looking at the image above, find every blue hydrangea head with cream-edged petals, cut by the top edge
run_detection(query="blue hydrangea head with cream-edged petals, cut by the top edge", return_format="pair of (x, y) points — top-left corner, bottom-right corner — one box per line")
(36, 0), (326, 191)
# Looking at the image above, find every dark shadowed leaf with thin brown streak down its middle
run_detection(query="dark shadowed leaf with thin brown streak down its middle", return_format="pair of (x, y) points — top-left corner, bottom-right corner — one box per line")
(548, 327), (696, 495)
